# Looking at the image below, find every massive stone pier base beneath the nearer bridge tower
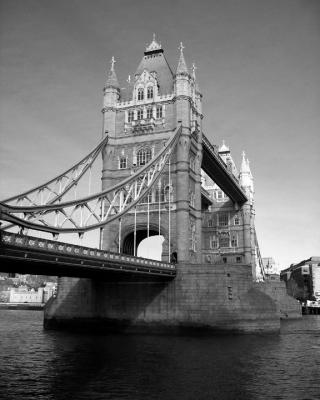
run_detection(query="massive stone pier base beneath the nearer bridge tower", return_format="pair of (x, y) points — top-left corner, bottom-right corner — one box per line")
(44, 264), (280, 334)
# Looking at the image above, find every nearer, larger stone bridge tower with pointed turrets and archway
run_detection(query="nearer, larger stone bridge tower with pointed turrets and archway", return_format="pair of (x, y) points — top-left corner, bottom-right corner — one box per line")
(101, 36), (202, 262)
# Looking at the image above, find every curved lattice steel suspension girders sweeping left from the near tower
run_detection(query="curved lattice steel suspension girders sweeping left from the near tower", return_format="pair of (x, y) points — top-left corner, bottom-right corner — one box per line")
(0, 126), (181, 235)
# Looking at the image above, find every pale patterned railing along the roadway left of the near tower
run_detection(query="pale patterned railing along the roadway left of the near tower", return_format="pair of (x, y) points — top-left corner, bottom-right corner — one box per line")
(1, 231), (176, 271)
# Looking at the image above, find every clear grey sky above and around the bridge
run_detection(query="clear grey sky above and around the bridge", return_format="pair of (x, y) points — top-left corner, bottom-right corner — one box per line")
(0, 0), (320, 268)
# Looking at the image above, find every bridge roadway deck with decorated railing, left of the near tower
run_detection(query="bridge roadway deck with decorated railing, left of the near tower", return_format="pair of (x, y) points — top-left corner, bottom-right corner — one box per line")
(0, 230), (176, 282)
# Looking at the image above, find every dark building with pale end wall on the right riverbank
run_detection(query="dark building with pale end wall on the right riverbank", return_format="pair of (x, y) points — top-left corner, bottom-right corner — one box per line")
(280, 257), (320, 301)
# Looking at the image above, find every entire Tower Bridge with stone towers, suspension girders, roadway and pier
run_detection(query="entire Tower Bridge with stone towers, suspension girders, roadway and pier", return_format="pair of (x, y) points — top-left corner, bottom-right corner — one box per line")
(0, 38), (300, 332)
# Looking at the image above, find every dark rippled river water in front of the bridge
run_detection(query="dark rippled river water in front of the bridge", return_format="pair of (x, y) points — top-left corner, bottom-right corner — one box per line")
(0, 310), (320, 400)
